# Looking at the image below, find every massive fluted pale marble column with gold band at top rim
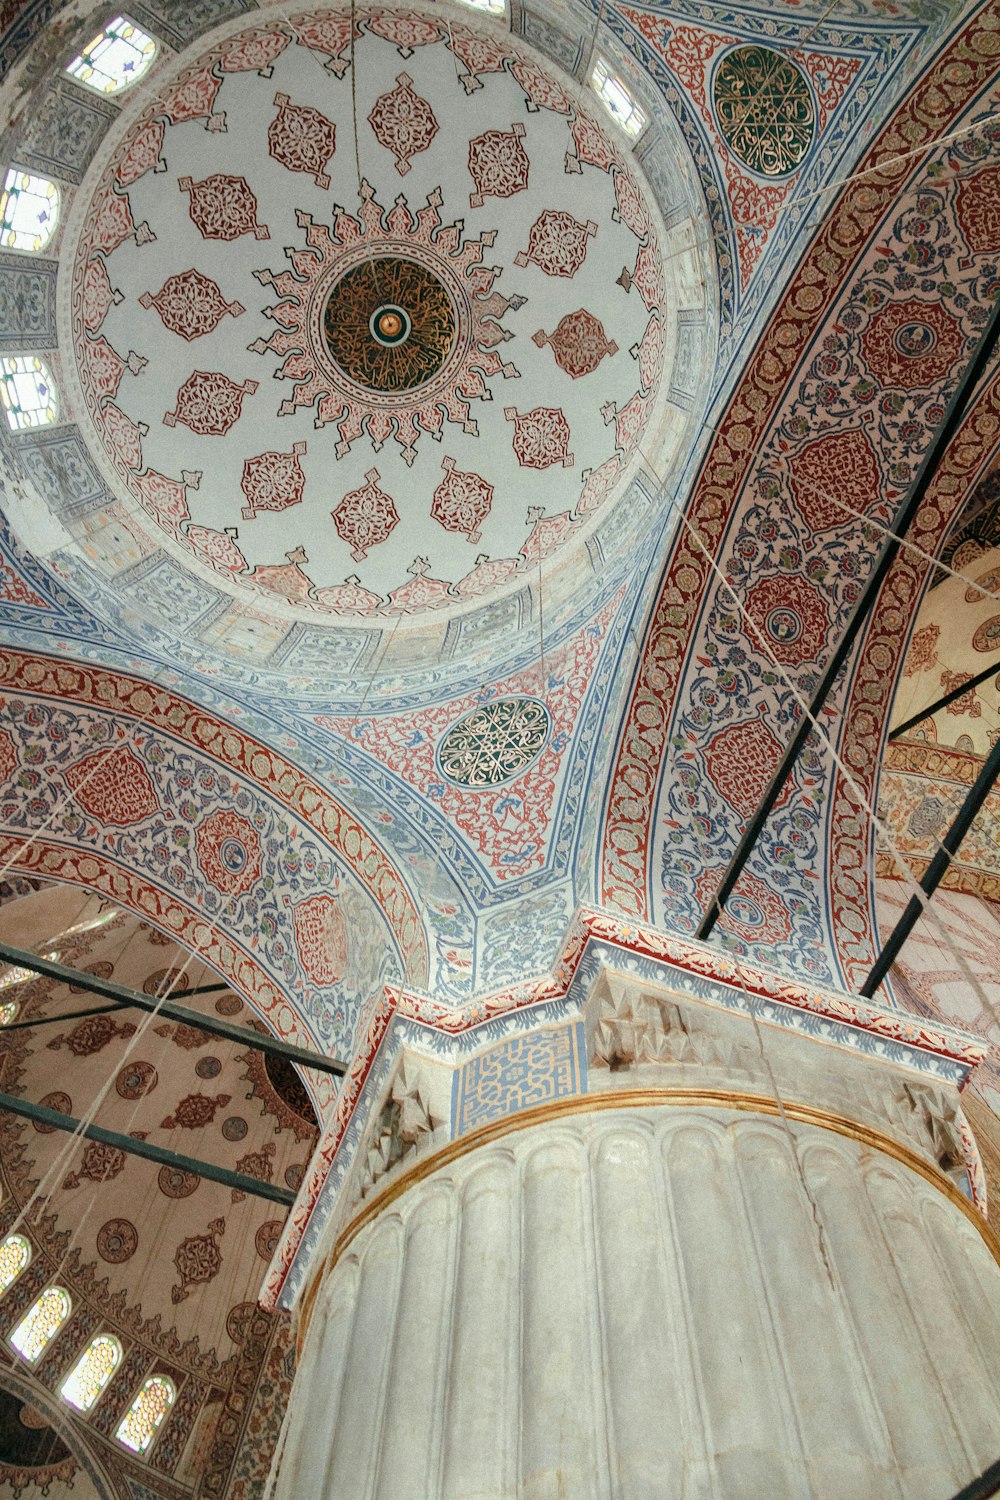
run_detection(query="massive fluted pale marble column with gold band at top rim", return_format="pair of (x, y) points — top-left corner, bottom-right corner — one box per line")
(277, 1098), (1000, 1500)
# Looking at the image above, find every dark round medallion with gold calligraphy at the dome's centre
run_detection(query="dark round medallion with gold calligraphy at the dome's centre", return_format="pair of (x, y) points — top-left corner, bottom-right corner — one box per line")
(322, 255), (456, 393)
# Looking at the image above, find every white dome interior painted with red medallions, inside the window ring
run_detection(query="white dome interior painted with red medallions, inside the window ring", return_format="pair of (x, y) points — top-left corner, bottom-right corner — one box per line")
(60, 2), (693, 623)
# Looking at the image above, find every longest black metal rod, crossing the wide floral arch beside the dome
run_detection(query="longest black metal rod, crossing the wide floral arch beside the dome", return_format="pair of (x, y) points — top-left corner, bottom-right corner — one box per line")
(696, 297), (1000, 941)
